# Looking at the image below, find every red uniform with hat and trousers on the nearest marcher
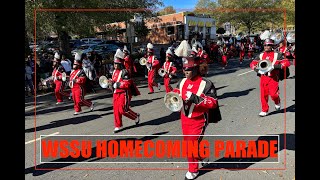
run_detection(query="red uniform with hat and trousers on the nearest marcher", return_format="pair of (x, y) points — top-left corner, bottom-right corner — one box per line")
(173, 57), (221, 176)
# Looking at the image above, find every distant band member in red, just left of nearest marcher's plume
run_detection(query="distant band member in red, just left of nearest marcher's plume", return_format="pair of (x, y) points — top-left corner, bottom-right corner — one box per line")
(162, 49), (177, 93)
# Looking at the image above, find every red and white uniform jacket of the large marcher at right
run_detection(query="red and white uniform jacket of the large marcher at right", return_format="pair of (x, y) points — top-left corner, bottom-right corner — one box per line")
(250, 51), (290, 79)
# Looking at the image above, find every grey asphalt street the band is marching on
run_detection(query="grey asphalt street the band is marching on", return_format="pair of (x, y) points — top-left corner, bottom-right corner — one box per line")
(25, 59), (295, 180)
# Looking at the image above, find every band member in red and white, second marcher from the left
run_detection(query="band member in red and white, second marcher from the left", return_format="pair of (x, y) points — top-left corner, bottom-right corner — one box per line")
(69, 53), (94, 115)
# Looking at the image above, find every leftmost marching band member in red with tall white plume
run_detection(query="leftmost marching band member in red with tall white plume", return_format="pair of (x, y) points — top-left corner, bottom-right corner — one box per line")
(52, 53), (70, 104)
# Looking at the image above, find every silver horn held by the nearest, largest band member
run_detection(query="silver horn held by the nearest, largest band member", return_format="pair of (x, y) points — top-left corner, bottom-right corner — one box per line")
(164, 92), (183, 112)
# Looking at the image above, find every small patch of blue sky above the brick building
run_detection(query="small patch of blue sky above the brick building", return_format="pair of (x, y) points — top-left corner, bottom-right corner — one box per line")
(162, 0), (198, 12)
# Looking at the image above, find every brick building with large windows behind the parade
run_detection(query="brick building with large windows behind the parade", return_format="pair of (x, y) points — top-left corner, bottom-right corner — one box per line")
(97, 12), (216, 44)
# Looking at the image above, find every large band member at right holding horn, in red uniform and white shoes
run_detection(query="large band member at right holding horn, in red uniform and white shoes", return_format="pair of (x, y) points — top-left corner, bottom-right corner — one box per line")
(250, 38), (290, 117)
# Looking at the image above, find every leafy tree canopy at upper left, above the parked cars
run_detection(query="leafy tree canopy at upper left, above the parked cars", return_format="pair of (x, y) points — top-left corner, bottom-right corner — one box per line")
(25, 0), (163, 56)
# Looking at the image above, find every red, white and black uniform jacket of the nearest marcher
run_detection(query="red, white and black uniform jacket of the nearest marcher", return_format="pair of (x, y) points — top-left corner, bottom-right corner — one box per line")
(173, 76), (221, 122)
